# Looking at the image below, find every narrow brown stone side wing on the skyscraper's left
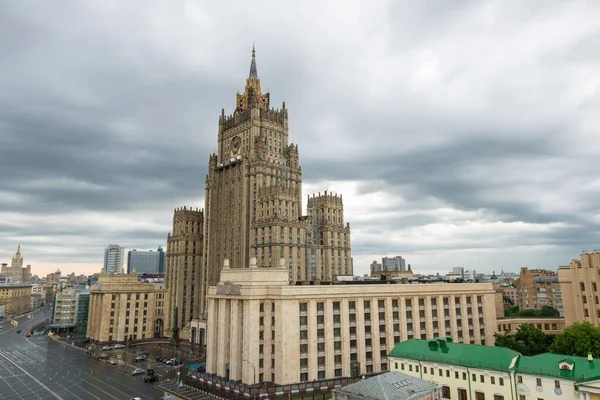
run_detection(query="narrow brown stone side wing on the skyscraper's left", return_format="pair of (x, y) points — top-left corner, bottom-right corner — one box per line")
(165, 207), (205, 338)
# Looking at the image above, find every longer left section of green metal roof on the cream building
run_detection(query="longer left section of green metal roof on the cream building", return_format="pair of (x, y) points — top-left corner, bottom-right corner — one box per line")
(388, 339), (520, 372)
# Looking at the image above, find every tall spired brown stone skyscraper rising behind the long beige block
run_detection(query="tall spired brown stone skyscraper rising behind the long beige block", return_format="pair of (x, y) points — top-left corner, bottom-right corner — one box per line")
(167, 49), (353, 336)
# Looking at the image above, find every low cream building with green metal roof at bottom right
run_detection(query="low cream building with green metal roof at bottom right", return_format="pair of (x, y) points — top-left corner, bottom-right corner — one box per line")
(389, 338), (600, 400)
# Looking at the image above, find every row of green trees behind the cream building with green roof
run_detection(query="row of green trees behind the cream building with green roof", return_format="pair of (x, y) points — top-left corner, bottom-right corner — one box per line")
(495, 321), (600, 357)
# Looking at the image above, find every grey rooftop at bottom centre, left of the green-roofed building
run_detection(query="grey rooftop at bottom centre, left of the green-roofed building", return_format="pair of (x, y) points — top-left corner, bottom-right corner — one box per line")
(337, 371), (438, 400)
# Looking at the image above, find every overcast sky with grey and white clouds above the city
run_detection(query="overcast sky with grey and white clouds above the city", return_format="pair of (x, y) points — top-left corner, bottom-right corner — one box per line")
(0, 0), (600, 274)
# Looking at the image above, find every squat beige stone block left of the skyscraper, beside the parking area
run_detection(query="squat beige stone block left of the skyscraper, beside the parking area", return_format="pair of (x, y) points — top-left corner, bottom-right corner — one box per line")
(87, 274), (166, 343)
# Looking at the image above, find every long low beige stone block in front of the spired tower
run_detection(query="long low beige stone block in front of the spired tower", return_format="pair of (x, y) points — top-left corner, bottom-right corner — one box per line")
(206, 262), (502, 384)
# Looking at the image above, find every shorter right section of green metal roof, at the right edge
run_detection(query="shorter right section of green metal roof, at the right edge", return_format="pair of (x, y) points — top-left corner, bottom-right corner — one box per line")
(517, 353), (600, 382)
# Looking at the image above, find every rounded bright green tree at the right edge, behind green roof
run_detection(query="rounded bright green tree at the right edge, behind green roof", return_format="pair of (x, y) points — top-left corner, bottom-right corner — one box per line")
(550, 321), (600, 357)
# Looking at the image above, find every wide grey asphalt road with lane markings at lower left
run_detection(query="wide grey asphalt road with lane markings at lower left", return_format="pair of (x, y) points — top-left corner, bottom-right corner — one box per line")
(0, 312), (163, 400)
